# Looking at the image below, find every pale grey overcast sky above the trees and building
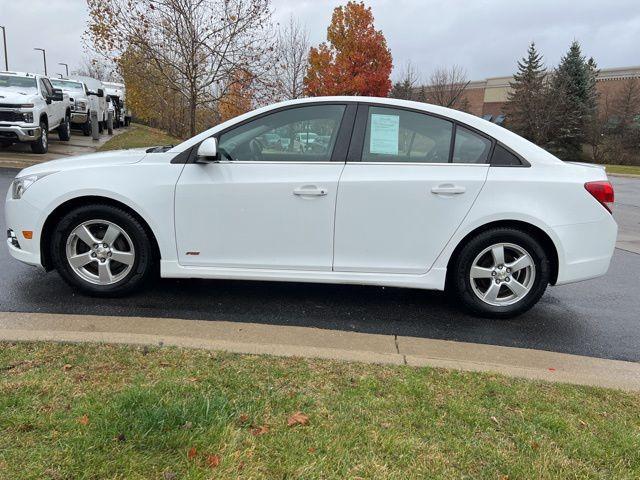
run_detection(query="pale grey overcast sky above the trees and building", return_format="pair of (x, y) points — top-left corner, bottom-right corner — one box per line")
(0, 0), (640, 80)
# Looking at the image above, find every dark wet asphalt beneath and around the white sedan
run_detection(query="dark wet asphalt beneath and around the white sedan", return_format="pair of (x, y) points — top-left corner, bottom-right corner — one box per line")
(0, 169), (640, 362)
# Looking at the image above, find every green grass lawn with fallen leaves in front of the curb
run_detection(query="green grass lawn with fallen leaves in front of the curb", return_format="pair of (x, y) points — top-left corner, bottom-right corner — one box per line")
(0, 343), (640, 480)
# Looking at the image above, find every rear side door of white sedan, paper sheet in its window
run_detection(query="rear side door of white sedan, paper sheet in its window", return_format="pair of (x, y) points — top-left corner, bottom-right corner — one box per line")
(333, 104), (493, 274)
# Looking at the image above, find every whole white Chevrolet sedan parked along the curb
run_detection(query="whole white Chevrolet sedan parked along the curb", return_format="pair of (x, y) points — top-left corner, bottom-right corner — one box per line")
(6, 97), (617, 317)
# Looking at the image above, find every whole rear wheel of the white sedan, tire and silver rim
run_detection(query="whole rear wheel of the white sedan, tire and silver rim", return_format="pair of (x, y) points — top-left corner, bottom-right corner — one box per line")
(449, 228), (551, 318)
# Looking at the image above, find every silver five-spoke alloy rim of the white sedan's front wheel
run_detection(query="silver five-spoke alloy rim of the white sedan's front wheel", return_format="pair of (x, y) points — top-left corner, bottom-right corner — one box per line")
(66, 220), (135, 285)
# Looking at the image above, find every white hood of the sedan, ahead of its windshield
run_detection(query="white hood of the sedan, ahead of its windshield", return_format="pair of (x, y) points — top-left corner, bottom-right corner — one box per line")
(17, 148), (147, 177)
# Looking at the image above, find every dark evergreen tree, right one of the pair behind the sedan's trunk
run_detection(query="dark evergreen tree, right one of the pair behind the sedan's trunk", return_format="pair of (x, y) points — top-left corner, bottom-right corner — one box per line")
(552, 41), (597, 160)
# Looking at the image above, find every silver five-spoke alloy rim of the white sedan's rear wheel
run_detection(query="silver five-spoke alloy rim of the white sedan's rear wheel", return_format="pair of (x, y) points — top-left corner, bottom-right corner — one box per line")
(469, 243), (536, 307)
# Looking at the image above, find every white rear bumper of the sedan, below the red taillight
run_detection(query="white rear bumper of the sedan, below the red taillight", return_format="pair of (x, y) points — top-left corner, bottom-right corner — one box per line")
(553, 214), (618, 285)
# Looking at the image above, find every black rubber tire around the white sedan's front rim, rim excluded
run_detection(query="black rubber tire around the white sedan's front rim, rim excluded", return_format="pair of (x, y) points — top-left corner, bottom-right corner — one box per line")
(51, 204), (156, 297)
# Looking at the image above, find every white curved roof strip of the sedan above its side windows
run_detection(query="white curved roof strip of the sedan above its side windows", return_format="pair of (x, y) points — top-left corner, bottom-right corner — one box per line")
(171, 96), (560, 163)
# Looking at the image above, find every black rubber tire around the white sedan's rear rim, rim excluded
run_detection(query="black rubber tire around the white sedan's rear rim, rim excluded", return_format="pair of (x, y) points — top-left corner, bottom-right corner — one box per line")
(447, 228), (551, 318)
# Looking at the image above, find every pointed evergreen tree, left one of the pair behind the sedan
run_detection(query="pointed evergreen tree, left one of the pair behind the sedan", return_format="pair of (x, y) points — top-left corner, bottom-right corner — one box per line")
(505, 42), (550, 145)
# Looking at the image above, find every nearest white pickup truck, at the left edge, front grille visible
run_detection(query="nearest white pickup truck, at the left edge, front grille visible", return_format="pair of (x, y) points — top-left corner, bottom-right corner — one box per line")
(0, 72), (71, 153)
